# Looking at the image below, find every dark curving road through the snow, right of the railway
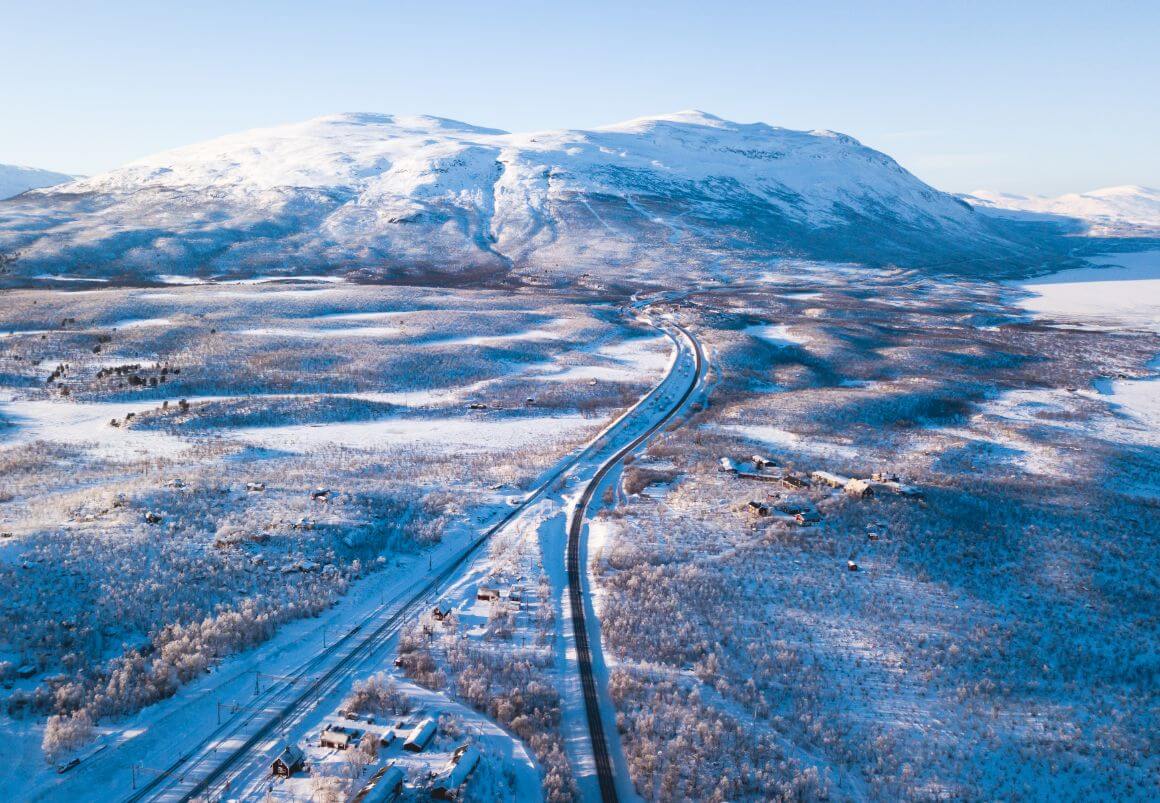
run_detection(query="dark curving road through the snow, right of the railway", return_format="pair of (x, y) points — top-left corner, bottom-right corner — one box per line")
(567, 324), (704, 803)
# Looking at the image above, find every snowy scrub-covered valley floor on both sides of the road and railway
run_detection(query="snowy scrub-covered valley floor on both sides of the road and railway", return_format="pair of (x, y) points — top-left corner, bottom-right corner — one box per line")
(0, 253), (1160, 801)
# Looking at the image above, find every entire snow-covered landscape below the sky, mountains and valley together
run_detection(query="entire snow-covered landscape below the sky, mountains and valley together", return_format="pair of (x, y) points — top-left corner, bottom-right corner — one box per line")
(0, 113), (1160, 803)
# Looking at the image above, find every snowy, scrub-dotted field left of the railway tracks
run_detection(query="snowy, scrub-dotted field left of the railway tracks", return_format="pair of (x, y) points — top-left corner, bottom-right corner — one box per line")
(0, 281), (668, 797)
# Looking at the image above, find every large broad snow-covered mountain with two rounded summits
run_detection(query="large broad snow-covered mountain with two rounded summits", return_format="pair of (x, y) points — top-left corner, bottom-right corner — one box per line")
(0, 111), (1044, 276)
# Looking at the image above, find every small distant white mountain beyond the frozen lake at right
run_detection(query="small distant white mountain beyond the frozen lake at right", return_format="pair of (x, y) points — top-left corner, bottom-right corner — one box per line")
(963, 185), (1160, 236)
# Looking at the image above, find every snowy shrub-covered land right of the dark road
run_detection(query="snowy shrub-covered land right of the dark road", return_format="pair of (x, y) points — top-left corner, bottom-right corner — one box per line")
(594, 268), (1160, 801)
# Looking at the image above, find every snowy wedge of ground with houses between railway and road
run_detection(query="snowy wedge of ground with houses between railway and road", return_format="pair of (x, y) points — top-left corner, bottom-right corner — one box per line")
(117, 308), (686, 800)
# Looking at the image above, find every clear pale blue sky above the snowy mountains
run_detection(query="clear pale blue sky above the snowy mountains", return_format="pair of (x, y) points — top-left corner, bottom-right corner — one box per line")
(0, 0), (1160, 194)
